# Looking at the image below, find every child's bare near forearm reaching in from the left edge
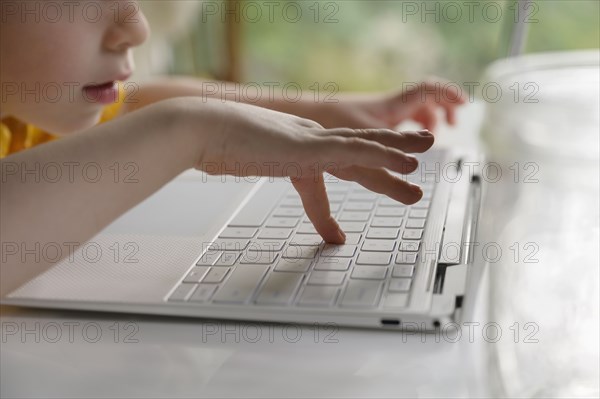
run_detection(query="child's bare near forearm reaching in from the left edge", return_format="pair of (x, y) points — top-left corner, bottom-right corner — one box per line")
(0, 99), (216, 295)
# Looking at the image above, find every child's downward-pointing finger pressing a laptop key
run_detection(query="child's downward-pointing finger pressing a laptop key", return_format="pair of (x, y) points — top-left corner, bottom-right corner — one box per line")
(292, 173), (346, 244)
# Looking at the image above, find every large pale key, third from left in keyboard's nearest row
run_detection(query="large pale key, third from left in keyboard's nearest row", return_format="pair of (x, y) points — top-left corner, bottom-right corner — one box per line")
(213, 265), (269, 303)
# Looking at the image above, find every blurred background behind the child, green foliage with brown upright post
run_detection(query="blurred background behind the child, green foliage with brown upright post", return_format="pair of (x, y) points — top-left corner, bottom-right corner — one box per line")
(137, 0), (600, 91)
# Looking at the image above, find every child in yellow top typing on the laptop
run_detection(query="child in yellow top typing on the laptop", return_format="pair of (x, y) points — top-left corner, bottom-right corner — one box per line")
(0, 0), (464, 295)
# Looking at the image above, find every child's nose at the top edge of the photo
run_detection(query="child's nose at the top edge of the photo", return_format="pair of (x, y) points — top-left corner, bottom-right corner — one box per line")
(104, 1), (150, 52)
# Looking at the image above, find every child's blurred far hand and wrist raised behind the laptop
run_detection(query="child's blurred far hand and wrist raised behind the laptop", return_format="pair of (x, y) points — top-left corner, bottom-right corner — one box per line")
(313, 80), (465, 131)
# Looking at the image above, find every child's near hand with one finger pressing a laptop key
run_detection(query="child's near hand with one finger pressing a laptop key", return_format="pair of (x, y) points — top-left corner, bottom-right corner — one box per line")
(195, 103), (434, 244)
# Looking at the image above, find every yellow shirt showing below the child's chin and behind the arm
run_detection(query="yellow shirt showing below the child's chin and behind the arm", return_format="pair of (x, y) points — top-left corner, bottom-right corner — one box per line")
(0, 86), (125, 158)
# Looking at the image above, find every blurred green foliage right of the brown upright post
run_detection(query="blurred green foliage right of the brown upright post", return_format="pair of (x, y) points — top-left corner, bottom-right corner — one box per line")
(176, 0), (600, 91)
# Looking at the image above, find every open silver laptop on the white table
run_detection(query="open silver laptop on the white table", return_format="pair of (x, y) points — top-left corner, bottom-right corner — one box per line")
(0, 1), (536, 331)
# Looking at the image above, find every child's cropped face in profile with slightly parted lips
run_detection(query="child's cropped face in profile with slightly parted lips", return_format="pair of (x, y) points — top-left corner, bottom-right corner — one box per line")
(0, 0), (149, 134)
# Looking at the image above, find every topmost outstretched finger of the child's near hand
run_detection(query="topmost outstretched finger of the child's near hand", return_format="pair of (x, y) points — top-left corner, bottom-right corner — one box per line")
(316, 129), (435, 152)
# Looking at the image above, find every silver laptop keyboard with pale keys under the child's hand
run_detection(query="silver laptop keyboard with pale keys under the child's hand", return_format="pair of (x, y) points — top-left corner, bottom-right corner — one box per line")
(168, 152), (442, 308)
